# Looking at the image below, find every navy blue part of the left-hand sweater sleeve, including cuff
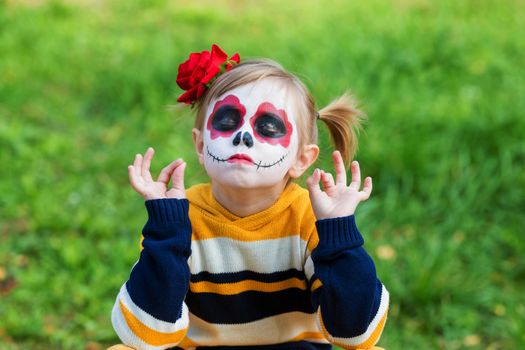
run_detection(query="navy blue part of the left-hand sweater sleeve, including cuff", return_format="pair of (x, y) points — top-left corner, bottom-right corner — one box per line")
(126, 199), (191, 322)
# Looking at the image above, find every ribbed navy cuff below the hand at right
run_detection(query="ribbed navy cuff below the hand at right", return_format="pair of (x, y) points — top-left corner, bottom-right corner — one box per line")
(315, 215), (365, 248)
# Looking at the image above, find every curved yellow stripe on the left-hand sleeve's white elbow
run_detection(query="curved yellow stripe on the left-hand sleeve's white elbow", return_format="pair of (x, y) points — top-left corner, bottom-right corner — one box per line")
(120, 302), (187, 346)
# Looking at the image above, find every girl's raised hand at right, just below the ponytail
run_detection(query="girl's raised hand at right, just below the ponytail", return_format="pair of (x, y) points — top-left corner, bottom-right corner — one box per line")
(306, 151), (372, 220)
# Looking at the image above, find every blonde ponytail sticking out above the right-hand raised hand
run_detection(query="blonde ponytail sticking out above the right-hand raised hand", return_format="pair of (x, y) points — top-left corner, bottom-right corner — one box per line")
(318, 93), (366, 168)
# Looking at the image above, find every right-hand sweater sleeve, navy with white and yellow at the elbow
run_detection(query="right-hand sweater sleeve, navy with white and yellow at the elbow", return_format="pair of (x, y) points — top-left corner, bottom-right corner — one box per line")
(311, 215), (388, 348)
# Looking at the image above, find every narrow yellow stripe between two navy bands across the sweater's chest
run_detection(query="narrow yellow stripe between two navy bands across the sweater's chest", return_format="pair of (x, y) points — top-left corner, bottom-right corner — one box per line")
(190, 277), (306, 295)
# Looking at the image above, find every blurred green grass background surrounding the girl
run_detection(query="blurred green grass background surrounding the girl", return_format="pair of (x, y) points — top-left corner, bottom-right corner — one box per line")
(0, 0), (525, 350)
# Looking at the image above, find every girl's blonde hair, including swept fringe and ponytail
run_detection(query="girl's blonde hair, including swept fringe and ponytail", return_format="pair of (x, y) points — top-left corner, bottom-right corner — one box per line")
(195, 59), (364, 167)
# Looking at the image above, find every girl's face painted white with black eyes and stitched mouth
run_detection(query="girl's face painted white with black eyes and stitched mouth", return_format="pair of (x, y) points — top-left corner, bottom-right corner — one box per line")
(203, 79), (298, 188)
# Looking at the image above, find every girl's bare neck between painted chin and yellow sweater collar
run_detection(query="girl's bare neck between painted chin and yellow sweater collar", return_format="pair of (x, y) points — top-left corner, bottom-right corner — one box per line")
(212, 179), (288, 217)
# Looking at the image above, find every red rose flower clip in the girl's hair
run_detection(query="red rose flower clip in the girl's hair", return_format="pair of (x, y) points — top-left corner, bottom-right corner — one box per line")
(176, 44), (241, 105)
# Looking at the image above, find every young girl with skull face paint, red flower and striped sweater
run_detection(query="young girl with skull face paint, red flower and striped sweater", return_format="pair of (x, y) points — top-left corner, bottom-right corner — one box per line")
(112, 45), (389, 349)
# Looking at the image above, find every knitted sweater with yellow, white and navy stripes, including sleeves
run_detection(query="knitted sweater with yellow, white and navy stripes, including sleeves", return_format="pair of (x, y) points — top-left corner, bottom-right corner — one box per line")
(112, 183), (389, 349)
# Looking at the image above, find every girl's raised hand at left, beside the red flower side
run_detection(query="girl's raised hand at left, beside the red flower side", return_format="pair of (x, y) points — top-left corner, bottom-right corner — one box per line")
(128, 147), (186, 200)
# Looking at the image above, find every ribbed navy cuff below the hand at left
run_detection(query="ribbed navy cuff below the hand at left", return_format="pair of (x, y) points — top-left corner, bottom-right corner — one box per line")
(144, 198), (190, 227)
